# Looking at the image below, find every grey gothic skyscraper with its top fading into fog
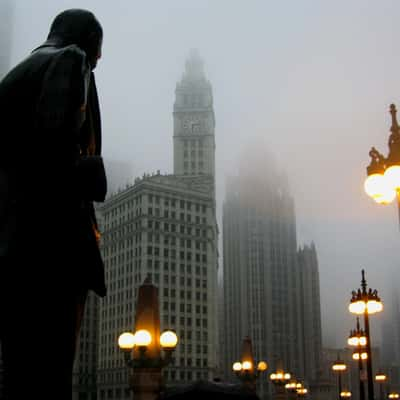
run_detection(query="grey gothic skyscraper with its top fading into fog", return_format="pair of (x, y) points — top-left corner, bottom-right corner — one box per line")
(221, 158), (321, 398)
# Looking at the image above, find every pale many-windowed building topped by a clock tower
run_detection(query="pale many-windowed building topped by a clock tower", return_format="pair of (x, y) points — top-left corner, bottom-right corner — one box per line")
(98, 52), (218, 400)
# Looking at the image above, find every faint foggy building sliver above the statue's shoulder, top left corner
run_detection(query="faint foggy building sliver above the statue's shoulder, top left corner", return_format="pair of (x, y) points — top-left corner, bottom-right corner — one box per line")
(0, 0), (14, 79)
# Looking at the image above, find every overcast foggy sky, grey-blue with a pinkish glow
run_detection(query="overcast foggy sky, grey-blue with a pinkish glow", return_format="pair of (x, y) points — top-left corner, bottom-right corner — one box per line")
(7, 0), (400, 346)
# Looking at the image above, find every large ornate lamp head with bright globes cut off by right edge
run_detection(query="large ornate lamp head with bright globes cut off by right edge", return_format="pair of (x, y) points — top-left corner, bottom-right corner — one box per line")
(364, 104), (400, 229)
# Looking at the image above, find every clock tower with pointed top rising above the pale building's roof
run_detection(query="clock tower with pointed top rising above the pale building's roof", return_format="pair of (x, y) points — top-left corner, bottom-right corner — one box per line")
(173, 50), (215, 180)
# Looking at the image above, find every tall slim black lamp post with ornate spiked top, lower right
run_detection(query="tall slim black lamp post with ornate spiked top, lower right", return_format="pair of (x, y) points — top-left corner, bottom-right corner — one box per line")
(349, 270), (383, 400)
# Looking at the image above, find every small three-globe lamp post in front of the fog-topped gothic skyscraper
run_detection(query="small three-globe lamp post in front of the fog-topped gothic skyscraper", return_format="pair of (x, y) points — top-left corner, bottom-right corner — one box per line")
(232, 336), (268, 392)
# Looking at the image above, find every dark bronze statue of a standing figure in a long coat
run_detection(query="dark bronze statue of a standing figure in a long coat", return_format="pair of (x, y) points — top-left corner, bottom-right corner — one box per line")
(0, 9), (106, 400)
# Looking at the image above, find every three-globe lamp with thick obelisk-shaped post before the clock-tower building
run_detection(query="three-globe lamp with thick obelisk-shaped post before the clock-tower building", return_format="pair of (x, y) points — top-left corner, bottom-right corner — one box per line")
(118, 277), (178, 400)
